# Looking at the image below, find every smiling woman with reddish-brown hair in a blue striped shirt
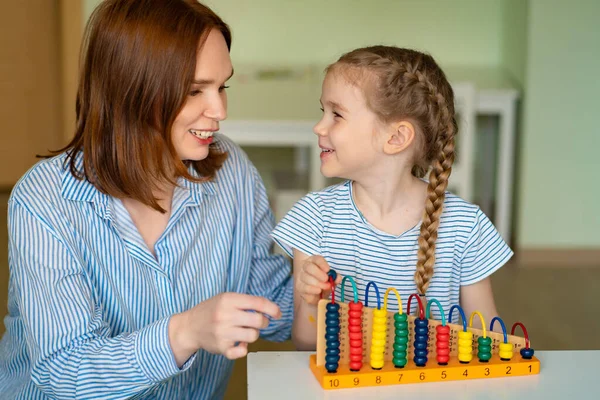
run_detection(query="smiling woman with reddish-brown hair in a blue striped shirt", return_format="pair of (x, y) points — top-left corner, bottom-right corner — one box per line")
(0, 0), (292, 399)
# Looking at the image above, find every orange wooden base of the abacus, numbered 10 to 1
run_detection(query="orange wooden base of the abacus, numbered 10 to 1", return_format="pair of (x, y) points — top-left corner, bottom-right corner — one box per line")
(310, 354), (540, 389)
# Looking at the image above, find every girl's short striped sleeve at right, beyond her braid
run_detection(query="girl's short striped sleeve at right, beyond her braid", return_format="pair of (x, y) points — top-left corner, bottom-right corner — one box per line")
(461, 208), (514, 285)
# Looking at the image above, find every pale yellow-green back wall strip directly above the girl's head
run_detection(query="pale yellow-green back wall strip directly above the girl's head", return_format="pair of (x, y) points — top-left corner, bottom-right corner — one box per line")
(84, 0), (504, 66)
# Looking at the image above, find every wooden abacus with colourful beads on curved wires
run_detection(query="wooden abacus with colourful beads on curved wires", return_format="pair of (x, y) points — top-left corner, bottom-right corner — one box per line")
(309, 271), (540, 389)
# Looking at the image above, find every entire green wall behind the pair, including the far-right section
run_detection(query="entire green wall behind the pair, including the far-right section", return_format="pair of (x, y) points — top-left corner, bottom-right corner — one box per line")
(84, 0), (600, 248)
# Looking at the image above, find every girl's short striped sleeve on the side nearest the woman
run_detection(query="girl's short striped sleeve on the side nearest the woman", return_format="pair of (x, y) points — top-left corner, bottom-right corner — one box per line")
(272, 193), (323, 257)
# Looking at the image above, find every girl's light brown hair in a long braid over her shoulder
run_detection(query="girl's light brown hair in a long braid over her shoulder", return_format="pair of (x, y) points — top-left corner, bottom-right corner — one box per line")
(328, 46), (458, 295)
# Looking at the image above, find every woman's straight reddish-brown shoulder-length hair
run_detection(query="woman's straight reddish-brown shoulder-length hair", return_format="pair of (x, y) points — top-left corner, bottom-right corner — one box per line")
(53, 0), (231, 211)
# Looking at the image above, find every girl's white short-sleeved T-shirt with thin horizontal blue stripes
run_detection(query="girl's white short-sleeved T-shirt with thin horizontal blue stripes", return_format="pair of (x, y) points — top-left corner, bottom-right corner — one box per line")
(272, 181), (513, 319)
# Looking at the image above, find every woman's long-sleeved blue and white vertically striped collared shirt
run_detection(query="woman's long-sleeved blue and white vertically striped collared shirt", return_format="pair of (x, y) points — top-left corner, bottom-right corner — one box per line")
(0, 135), (293, 399)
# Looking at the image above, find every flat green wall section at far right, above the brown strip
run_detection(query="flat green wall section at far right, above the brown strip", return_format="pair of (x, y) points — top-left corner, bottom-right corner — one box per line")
(518, 0), (600, 248)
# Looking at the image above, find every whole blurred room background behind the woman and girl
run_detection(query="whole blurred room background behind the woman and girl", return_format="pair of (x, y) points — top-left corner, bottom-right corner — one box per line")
(0, 0), (600, 399)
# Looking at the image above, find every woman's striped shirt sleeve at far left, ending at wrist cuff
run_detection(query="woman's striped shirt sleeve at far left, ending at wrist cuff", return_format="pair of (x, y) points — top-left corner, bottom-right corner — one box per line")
(8, 201), (195, 399)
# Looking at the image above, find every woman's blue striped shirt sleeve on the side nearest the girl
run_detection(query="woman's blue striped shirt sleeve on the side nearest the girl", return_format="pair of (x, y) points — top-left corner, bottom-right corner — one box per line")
(245, 167), (294, 341)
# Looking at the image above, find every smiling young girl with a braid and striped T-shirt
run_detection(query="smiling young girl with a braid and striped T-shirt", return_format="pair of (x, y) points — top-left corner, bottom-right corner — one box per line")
(273, 46), (513, 349)
